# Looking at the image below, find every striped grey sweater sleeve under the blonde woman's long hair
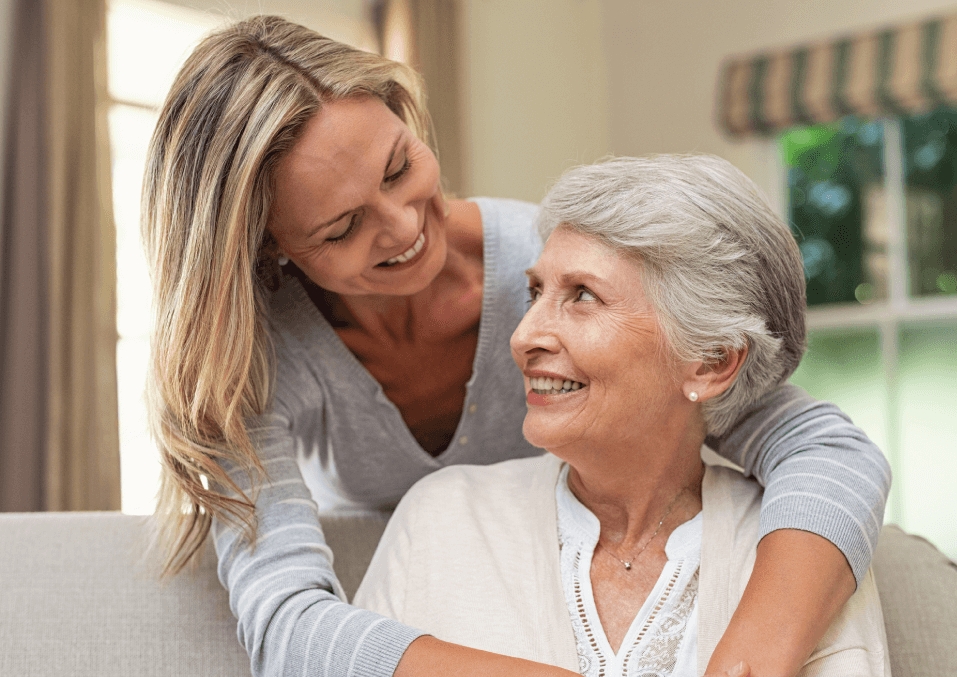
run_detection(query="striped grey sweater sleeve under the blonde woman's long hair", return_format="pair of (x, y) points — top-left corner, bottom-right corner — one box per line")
(213, 406), (422, 677)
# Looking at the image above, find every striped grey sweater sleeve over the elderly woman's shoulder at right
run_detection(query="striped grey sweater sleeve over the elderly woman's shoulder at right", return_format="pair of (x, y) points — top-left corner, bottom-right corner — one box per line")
(707, 384), (891, 584)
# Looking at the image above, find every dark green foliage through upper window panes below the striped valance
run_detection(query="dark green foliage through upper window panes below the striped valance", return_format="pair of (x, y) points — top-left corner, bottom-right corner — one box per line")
(781, 108), (957, 306)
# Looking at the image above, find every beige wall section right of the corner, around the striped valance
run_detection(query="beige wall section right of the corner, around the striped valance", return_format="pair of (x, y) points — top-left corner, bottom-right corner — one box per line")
(602, 0), (957, 190)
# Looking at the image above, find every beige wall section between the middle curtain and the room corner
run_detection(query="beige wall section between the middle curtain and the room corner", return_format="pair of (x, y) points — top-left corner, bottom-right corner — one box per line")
(461, 0), (609, 202)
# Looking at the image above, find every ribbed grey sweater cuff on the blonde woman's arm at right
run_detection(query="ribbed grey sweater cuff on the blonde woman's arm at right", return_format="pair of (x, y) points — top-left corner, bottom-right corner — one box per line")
(760, 494), (877, 585)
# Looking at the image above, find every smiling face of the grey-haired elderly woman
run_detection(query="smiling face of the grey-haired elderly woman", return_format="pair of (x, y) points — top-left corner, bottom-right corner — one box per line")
(511, 227), (684, 456)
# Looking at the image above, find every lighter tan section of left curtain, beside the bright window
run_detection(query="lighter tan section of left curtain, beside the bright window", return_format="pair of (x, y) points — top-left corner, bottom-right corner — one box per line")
(45, 0), (120, 510)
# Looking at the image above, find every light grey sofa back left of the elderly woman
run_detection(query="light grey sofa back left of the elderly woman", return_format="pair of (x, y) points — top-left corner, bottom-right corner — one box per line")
(0, 513), (385, 677)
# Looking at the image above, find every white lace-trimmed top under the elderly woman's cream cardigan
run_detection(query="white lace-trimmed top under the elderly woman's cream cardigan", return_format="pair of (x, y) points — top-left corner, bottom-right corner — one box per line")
(555, 464), (702, 677)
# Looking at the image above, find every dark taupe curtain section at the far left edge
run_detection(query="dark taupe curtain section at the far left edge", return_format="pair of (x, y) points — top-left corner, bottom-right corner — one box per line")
(0, 0), (48, 512)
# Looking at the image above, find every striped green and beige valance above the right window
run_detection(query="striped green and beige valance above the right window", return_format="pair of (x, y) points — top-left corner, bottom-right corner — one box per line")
(718, 15), (957, 136)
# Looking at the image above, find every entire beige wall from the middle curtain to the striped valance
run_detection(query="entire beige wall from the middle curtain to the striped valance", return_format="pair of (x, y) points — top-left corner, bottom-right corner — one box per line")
(459, 0), (957, 206)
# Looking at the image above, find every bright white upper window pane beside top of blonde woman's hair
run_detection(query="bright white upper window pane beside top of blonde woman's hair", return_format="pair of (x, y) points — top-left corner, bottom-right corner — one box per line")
(107, 0), (225, 106)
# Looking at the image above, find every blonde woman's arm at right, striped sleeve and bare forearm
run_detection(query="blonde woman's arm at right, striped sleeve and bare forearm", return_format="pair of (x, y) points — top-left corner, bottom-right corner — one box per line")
(708, 385), (891, 677)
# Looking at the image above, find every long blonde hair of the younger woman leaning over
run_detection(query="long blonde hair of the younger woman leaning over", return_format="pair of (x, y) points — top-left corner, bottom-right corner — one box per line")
(142, 16), (430, 574)
